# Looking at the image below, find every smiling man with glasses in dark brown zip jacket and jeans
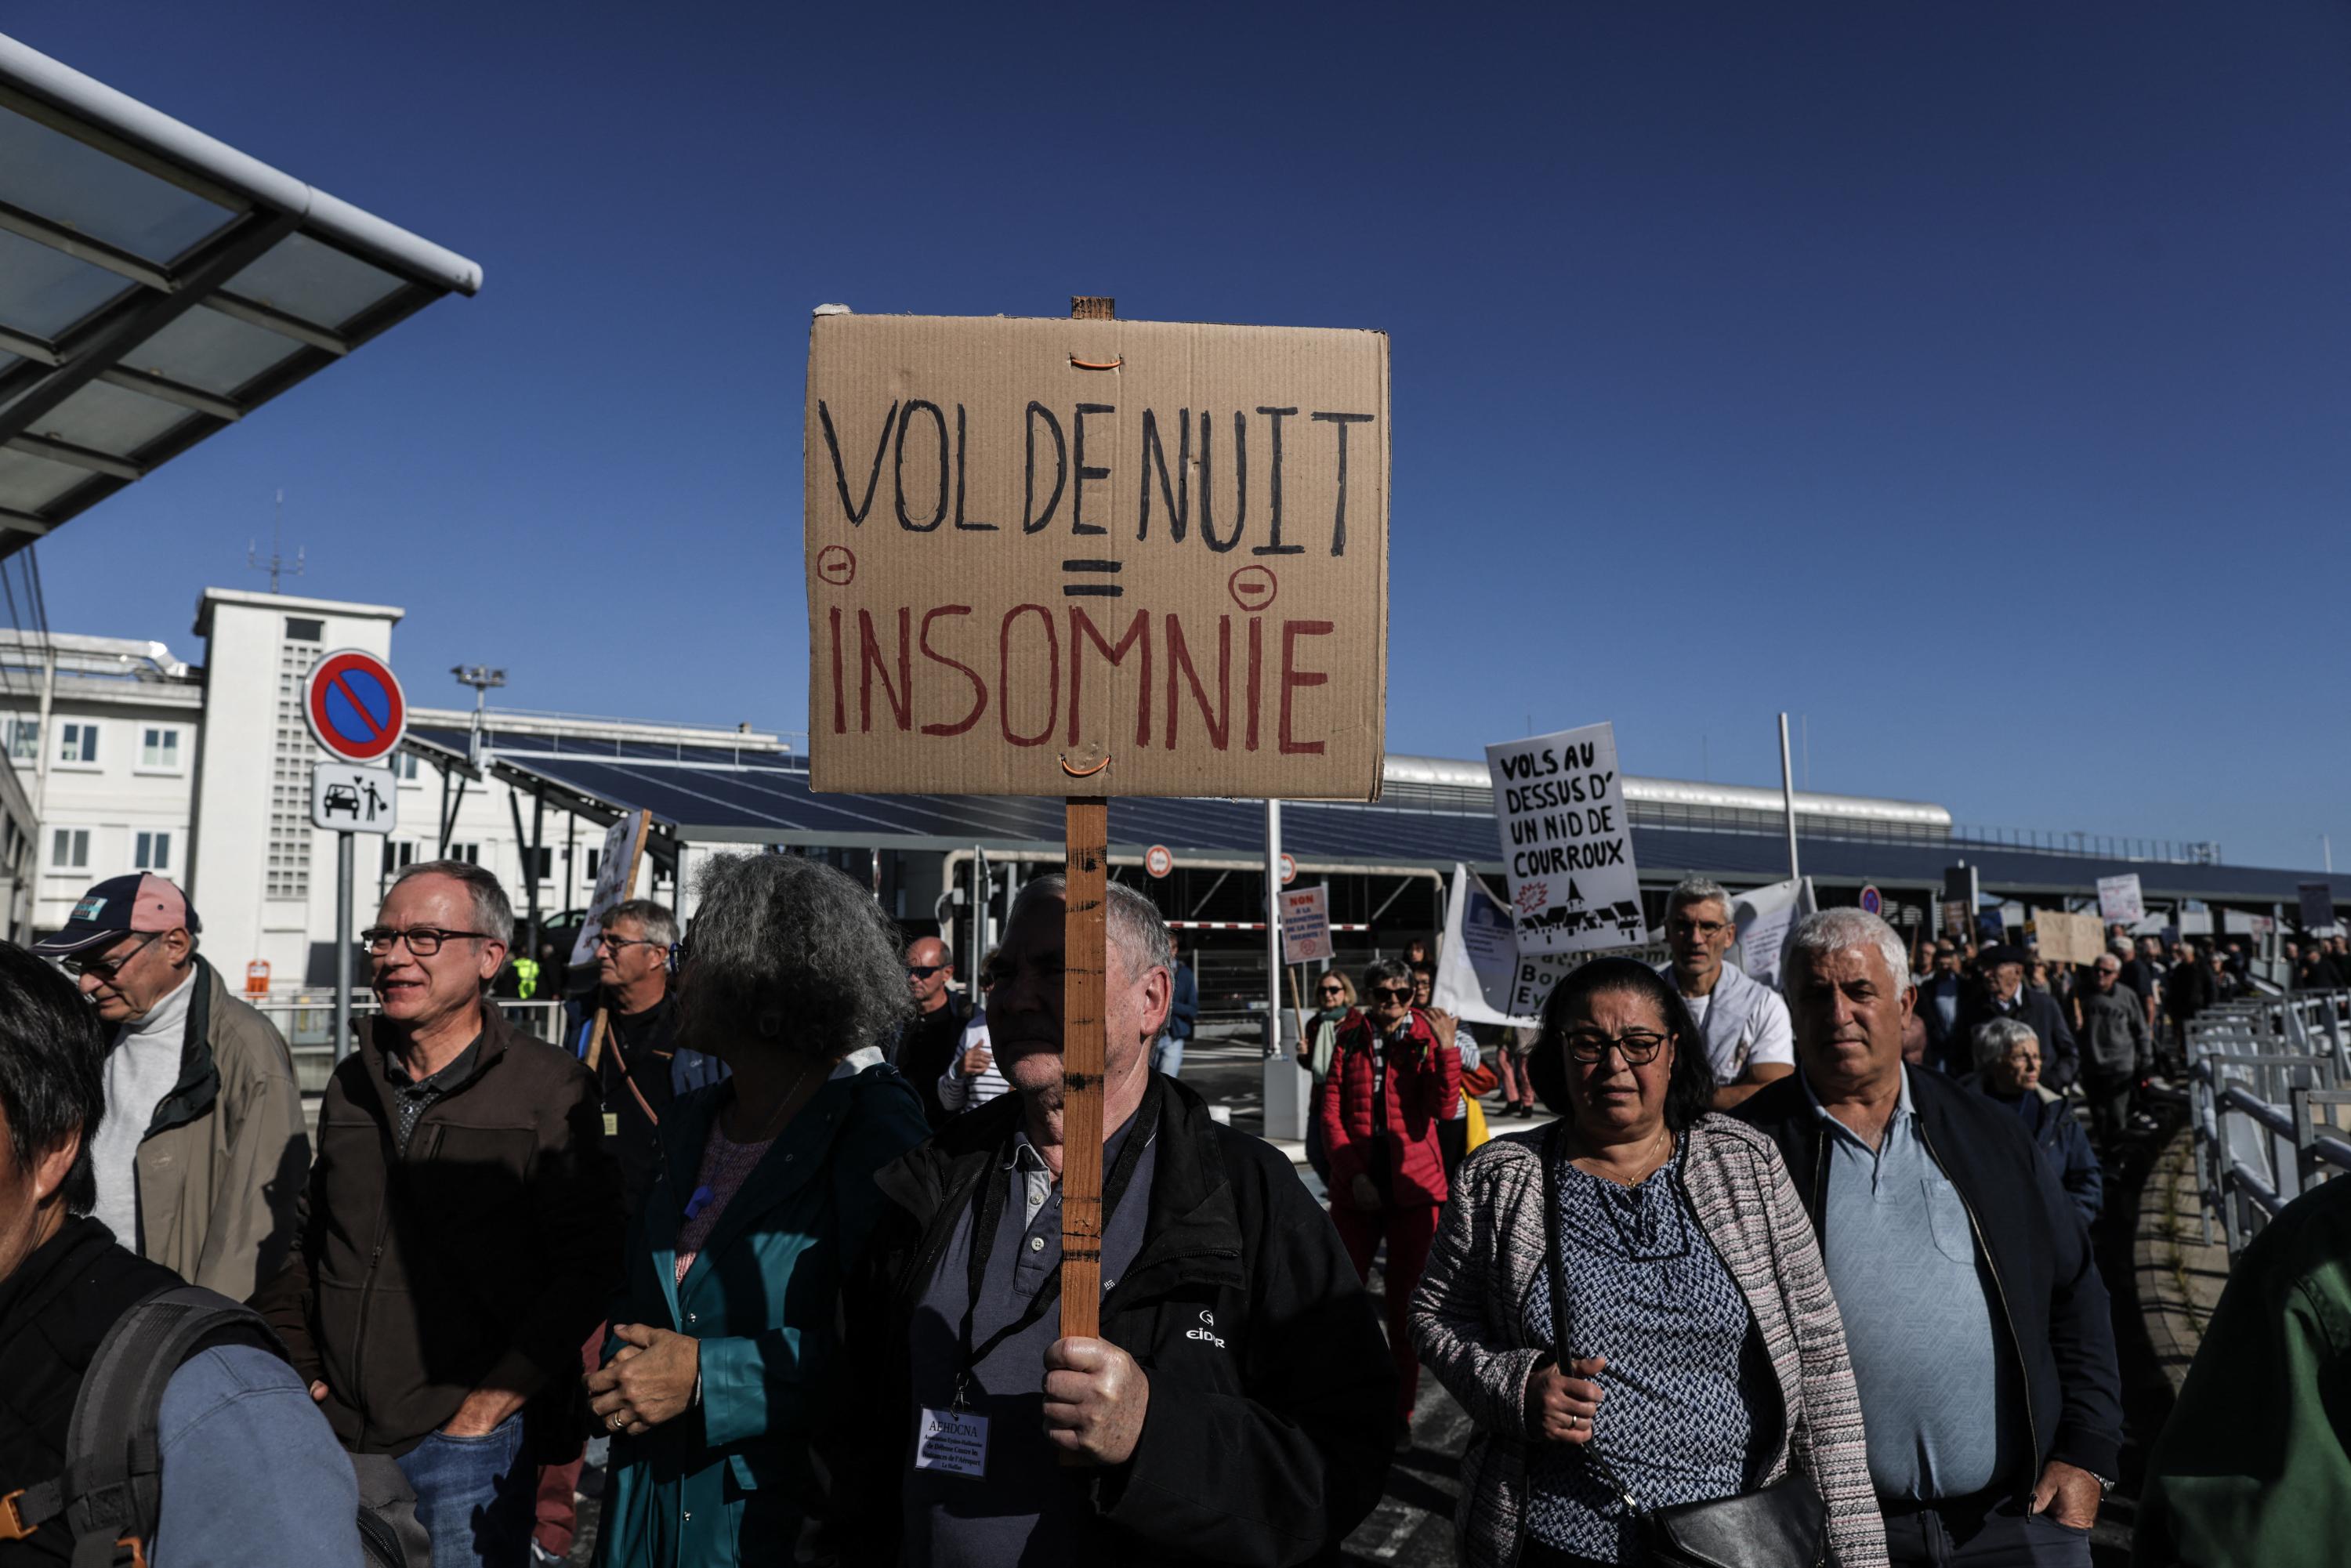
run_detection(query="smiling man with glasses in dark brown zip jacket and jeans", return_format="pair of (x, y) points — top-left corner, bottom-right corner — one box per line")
(254, 860), (623, 1568)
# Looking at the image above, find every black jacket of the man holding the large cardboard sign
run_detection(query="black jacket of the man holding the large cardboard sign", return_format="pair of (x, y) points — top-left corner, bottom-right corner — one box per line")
(802, 1079), (1396, 1566)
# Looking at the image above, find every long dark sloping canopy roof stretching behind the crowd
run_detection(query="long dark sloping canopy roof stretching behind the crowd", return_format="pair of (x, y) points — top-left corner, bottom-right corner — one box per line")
(409, 729), (2316, 905)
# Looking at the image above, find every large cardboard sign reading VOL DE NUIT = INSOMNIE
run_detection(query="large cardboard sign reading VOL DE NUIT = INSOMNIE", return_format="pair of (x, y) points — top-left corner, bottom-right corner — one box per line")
(802, 315), (1389, 799)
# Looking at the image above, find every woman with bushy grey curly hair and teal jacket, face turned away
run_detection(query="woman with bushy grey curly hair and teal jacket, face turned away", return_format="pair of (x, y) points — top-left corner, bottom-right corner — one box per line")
(588, 853), (929, 1563)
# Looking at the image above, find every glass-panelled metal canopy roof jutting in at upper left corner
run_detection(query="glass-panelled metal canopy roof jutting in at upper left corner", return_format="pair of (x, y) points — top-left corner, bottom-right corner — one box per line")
(0, 35), (482, 557)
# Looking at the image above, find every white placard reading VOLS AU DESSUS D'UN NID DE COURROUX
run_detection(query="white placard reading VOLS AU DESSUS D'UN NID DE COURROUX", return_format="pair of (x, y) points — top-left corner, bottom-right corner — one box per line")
(1486, 724), (1648, 954)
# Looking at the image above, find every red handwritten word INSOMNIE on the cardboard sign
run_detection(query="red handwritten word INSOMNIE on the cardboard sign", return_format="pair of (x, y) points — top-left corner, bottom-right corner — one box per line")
(825, 604), (1338, 757)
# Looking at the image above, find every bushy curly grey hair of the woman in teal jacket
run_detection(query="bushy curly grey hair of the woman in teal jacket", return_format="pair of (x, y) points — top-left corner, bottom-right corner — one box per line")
(682, 853), (915, 1060)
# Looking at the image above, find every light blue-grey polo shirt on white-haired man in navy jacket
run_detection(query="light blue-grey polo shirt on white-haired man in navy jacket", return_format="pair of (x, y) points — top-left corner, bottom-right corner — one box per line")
(1803, 1067), (2022, 1497)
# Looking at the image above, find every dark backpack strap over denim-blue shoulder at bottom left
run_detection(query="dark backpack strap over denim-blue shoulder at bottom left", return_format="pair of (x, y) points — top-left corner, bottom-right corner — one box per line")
(53, 1286), (284, 1568)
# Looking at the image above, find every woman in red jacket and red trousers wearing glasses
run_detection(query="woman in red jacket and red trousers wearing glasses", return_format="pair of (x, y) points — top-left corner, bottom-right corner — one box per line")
(1314, 959), (1462, 1453)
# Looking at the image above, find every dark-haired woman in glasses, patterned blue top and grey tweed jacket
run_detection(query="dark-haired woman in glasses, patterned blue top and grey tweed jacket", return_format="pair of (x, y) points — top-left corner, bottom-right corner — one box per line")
(1411, 959), (1886, 1568)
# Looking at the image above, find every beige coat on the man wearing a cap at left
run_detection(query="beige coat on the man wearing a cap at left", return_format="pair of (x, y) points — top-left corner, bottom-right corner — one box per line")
(136, 959), (310, 1300)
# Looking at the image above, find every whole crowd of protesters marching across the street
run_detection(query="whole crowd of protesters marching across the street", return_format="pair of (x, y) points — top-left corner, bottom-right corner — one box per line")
(0, 856), (2351, 1568)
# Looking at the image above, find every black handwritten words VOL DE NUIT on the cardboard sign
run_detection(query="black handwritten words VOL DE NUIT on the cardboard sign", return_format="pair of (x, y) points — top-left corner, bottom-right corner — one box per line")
(816, 397), (1378, 555)
